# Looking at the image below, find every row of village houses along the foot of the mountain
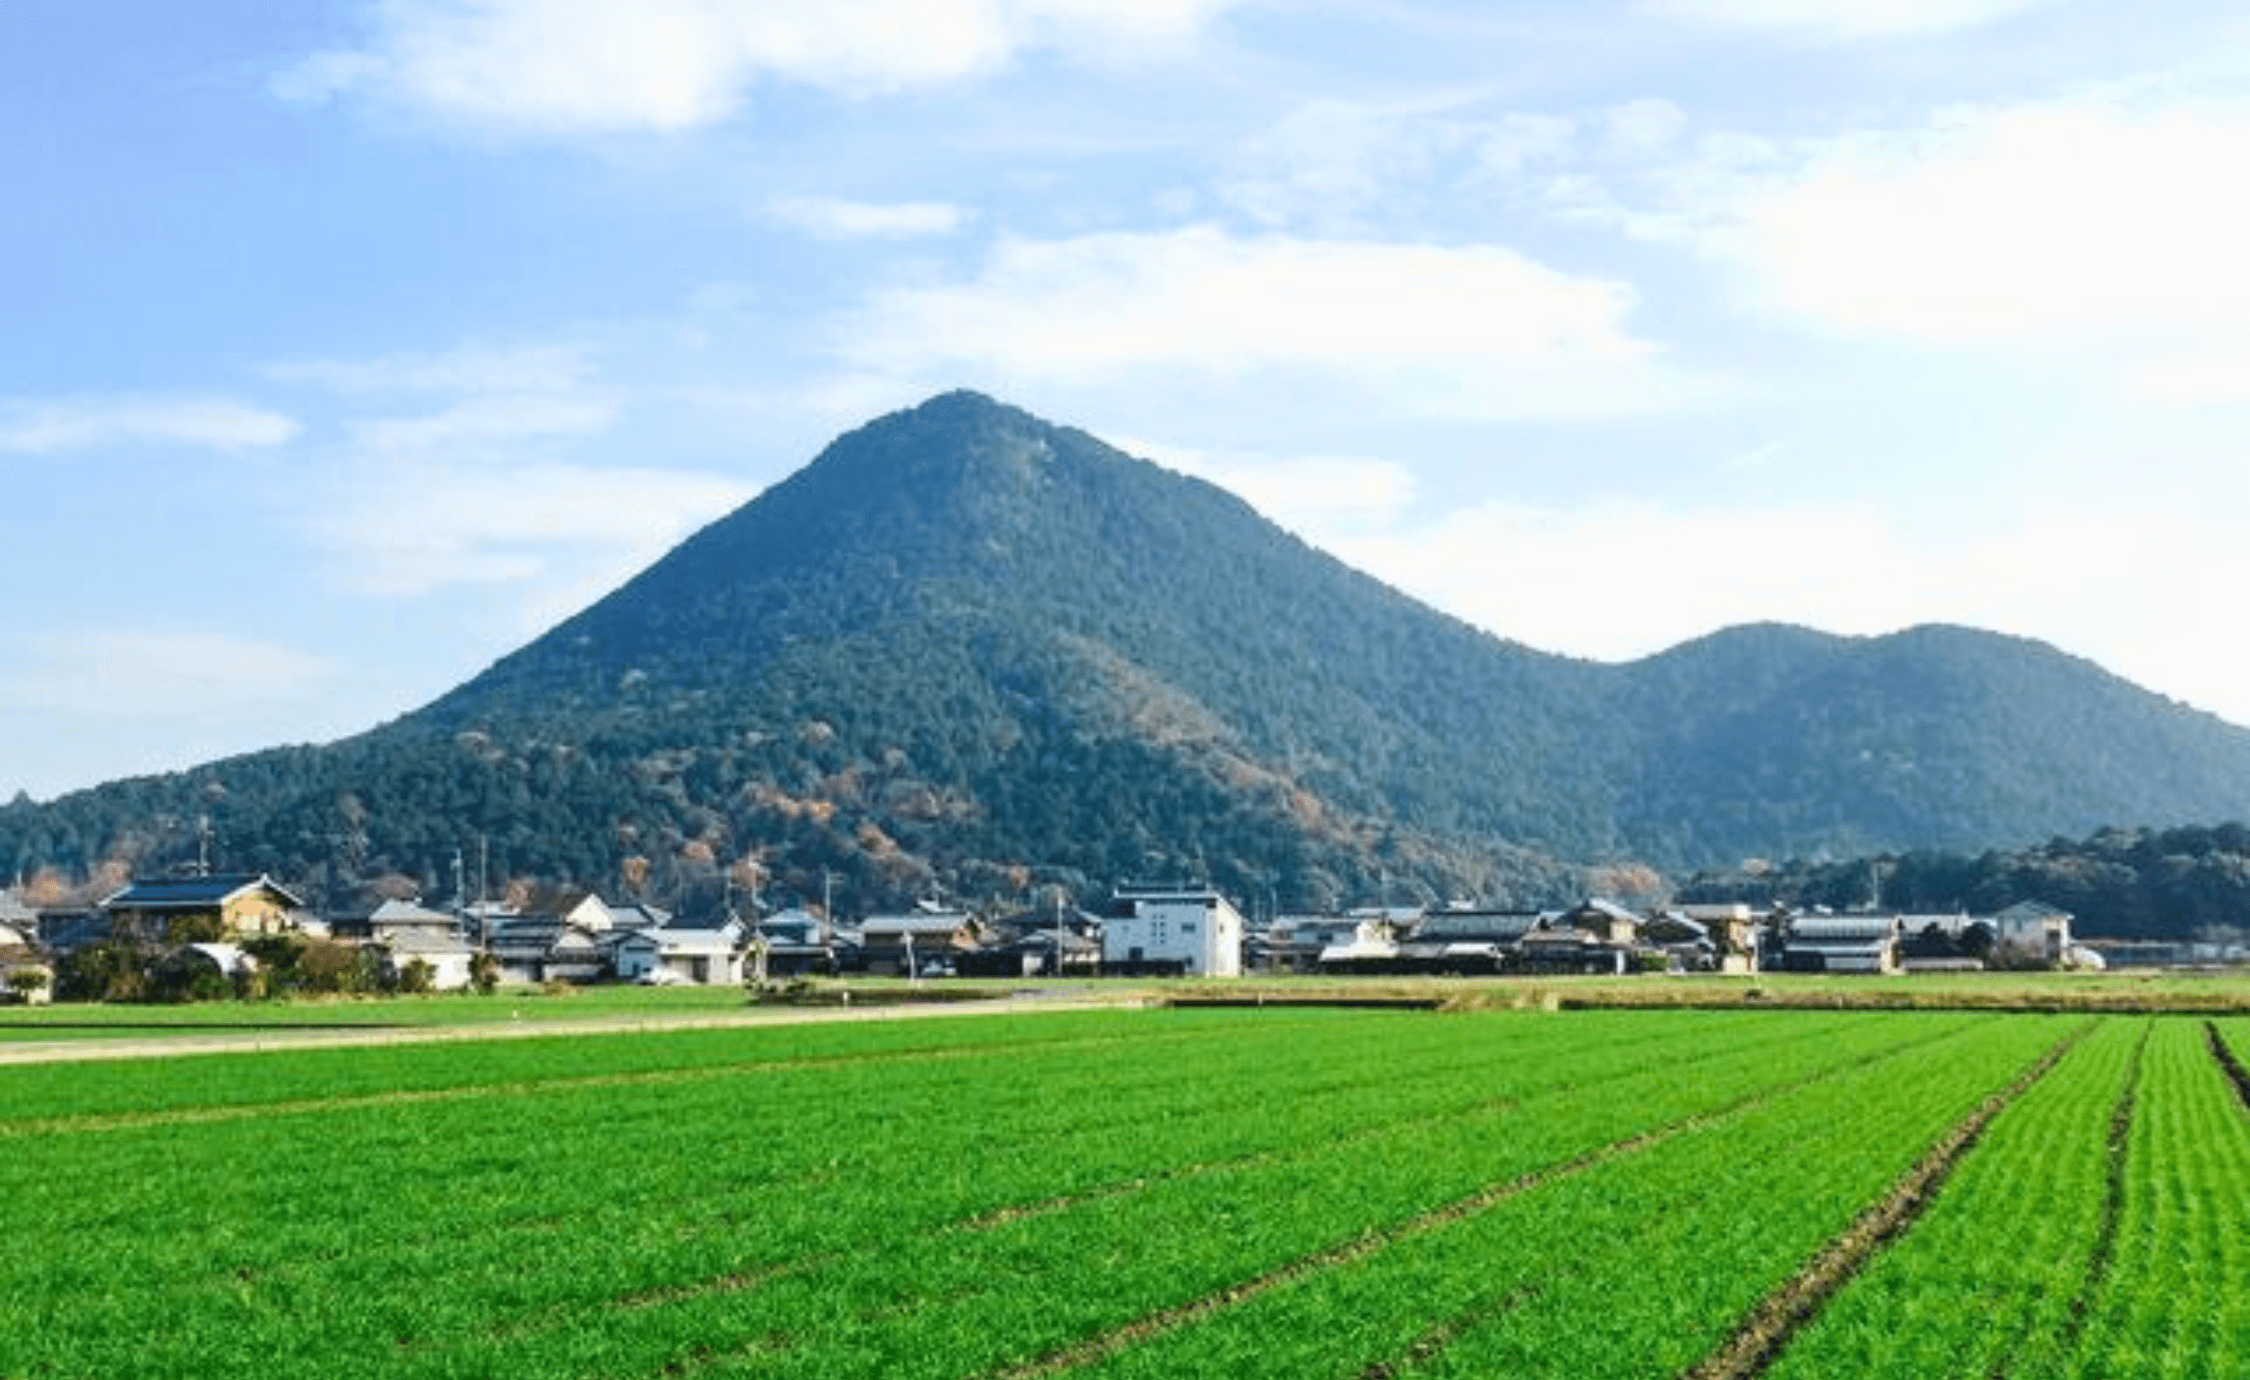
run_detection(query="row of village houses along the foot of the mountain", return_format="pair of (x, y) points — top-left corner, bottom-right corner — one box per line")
(0, 873), (2104, 1002)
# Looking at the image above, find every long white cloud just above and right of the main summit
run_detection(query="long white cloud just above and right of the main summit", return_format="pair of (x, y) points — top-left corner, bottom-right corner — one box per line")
(837, 227), (1679, 416)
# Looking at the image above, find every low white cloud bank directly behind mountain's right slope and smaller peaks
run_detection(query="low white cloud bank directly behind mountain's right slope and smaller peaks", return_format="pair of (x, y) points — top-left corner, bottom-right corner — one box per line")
(1312, 481), (2250, 725)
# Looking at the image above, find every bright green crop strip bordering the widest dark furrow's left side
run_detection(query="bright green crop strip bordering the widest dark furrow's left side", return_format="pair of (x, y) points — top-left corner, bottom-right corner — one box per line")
(1030, 1018), (2059, 1380)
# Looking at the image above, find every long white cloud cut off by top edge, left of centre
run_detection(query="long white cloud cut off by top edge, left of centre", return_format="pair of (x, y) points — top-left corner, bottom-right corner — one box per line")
(275, 0), (1238, 135)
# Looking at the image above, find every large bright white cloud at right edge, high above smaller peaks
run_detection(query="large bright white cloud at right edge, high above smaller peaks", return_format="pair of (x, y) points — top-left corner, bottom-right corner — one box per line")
(1674, 104), (2250, 358)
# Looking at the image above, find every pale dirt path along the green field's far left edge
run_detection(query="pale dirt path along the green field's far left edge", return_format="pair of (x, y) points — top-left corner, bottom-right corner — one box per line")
(0, 993), (1118, 1065)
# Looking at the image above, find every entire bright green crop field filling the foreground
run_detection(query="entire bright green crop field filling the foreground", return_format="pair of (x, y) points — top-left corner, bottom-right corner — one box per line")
(0, 997), (2250, 1380)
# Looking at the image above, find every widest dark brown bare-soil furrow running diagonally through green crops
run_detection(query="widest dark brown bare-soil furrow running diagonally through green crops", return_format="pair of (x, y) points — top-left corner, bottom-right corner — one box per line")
(1683, 1022), (2095, 1380)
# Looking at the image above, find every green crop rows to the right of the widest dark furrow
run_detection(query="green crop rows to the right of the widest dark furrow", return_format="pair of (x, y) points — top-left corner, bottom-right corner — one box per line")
(1771, 1020), (2250, 1380)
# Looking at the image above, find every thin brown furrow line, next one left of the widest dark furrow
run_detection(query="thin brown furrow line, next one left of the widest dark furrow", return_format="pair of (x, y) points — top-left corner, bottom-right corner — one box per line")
(990, 1017), (1980, 1380)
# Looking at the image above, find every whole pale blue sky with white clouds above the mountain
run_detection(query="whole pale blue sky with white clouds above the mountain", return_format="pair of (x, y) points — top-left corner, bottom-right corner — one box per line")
(0, 0), (2250, 799)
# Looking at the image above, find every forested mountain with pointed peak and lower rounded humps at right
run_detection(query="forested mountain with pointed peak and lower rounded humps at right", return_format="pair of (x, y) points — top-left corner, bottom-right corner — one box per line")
(0, 394), (2250, 905)
